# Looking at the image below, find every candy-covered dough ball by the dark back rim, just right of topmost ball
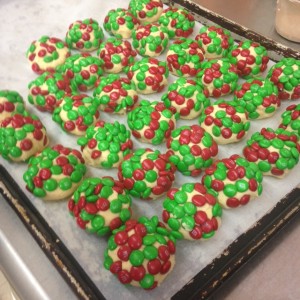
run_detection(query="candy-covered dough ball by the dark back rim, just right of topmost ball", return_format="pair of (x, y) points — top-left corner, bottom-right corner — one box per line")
(158, 7), (195, 39)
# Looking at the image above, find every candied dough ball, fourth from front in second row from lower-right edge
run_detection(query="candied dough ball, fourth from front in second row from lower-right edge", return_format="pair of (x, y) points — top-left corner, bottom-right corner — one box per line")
(199, 100), (250, 145)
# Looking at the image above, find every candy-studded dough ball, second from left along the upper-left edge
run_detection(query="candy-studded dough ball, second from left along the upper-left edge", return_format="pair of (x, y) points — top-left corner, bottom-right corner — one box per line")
(66, 18), (104, 51)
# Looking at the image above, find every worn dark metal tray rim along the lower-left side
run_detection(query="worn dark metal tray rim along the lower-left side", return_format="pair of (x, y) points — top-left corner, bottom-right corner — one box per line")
(0, 164), (105, 300)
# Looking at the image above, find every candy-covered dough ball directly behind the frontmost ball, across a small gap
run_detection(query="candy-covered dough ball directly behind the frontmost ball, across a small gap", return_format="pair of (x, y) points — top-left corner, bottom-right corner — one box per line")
(118, 148), (176, 200)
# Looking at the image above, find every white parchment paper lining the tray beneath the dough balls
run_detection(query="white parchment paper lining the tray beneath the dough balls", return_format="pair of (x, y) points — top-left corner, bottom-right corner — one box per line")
(0, 0), (300, 299)
